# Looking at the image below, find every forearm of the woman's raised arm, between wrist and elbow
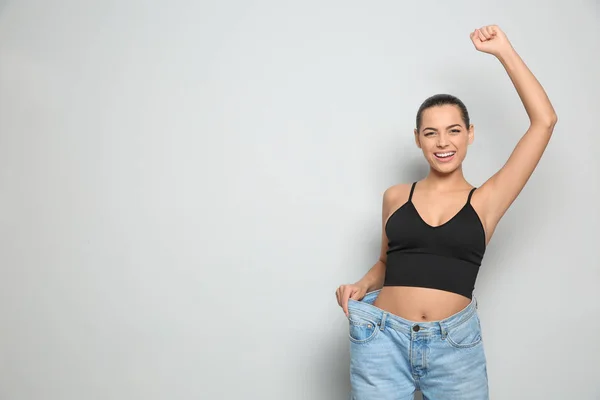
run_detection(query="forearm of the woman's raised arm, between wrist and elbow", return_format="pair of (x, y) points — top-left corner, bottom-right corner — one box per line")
(498, 46), (556, 126)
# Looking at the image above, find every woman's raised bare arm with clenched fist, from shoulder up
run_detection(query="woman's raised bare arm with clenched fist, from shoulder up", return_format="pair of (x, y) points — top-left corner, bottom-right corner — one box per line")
(471, 25), (557, 233)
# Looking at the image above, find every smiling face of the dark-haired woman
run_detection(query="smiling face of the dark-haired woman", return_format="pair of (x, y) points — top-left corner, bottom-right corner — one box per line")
(415, 104), (474, 173)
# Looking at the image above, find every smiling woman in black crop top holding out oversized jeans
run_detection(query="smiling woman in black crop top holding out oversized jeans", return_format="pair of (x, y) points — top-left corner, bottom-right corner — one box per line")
(336, 25), (557, 400)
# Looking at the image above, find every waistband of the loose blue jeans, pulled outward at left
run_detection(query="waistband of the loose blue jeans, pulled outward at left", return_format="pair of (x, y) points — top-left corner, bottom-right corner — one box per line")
(348, 289), (477, 336)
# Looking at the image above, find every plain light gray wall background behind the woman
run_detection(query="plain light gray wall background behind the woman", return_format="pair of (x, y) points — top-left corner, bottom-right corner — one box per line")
(0, 0), (600, 400)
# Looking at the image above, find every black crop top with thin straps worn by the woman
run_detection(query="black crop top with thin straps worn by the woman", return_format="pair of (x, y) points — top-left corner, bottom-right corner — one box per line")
(383, 182), (486, 299)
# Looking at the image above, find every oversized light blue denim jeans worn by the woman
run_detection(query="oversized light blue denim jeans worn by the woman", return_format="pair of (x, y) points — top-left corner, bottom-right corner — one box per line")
(348, 290), (489, 400)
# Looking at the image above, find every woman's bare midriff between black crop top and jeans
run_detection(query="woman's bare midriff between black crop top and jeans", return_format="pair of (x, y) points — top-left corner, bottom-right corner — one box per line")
(373, 286), (471, 322)
